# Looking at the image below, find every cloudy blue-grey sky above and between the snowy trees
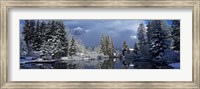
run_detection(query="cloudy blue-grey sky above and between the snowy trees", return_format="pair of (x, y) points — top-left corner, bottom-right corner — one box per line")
(20, 20), (171, 48)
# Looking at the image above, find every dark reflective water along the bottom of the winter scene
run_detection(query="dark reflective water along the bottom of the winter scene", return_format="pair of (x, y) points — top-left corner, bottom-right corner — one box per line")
(20, 58), (180, 69)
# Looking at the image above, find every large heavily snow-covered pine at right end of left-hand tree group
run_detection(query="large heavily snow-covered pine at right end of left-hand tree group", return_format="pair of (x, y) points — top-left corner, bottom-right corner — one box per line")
(41, 20), (68, 59)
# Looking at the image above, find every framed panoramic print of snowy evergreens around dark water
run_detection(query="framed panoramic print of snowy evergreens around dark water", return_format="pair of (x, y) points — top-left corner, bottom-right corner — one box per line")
(19, 19), (180, 69)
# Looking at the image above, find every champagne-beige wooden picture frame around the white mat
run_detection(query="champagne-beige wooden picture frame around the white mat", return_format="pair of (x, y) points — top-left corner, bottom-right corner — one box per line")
(0, 0), (200, 89)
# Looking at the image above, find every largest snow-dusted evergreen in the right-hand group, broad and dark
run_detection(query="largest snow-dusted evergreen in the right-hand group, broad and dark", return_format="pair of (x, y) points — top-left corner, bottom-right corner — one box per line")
(147, 20), (169, 60)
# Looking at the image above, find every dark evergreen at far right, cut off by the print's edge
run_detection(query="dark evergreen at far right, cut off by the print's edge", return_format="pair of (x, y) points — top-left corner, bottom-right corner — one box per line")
(171, 20), (180, 51)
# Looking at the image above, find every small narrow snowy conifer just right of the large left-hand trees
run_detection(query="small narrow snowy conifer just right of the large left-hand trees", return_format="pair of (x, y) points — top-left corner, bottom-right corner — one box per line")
(69, 37), (76, 56)
